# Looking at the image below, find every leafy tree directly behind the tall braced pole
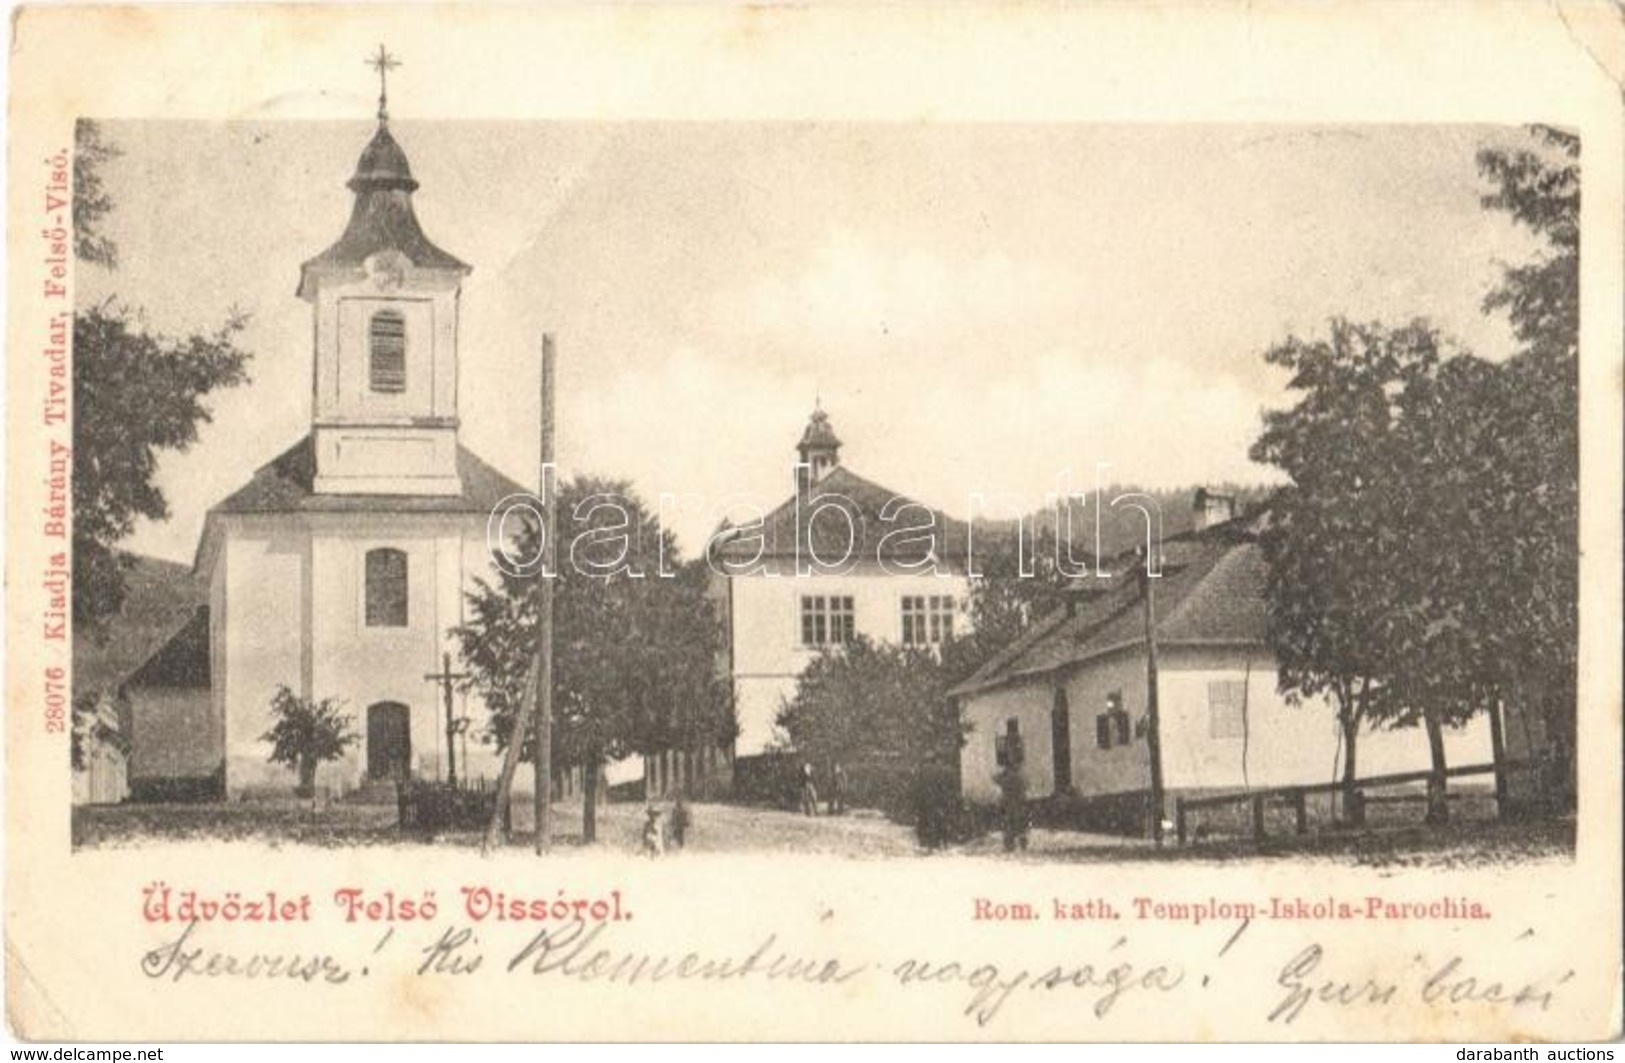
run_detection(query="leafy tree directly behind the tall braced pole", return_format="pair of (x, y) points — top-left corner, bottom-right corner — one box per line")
(453, 476), (736, 842)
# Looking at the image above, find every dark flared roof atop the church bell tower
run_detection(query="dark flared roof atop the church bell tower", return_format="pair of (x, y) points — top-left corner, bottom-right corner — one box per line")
(299, 122), (471, 296)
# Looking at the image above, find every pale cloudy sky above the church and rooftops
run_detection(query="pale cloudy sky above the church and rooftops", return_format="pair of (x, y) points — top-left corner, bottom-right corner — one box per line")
(78, 118), (1536, 561)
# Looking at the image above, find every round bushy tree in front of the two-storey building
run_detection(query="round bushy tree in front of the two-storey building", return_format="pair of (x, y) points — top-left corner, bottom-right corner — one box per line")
(777, 636), (964, 809)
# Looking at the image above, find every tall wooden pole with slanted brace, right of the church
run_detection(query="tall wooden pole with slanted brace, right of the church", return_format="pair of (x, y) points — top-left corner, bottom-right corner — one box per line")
(481, 333), (557, 853)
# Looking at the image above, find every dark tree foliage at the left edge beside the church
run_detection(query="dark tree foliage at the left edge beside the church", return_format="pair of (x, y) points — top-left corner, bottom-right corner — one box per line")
(73, 122), (249, 637)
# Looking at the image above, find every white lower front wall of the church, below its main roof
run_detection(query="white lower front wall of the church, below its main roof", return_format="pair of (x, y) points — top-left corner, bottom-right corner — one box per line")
(216, 514), (501, 796)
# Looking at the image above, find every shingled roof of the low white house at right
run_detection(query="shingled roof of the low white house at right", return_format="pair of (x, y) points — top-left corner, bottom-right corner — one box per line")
(949, 520), (1269, 697)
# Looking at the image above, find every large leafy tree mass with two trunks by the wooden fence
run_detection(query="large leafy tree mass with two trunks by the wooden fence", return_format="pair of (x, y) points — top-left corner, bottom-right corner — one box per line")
(1253, 322), (1560, 822)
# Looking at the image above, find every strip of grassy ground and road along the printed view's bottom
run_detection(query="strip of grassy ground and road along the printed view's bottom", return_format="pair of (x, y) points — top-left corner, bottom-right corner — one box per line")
(73, 798), (1575, 868)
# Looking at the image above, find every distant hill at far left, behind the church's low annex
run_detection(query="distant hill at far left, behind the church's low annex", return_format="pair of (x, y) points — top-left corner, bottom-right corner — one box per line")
(73, 553), (205, 697)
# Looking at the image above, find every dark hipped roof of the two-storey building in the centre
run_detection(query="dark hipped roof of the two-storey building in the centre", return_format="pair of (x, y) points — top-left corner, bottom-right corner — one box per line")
(715, 465), (969, 564)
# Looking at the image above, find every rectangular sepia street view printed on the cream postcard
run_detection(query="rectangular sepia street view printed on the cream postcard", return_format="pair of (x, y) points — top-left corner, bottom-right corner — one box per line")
(72, 99), (1581, 860)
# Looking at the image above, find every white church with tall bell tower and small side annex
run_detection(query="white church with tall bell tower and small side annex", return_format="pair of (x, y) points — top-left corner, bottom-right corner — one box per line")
(125, 87), (523, 796)
